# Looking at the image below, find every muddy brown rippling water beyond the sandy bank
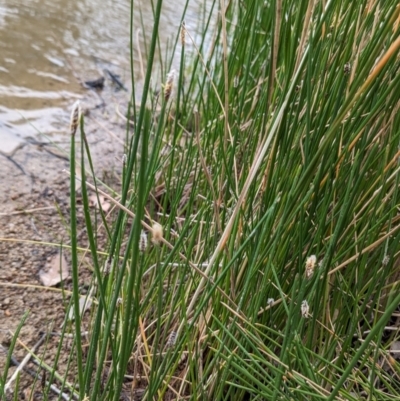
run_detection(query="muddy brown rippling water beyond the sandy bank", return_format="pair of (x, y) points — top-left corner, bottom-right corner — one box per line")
(0, 0), (212, 154)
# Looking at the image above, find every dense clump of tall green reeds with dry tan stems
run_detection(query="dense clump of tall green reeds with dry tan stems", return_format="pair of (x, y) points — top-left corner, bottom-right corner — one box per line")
(4, 0), (400, 401)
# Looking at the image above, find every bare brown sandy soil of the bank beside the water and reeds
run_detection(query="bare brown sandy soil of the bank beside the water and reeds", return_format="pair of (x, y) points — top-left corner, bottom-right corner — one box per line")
(0, 83), (128, 399)
